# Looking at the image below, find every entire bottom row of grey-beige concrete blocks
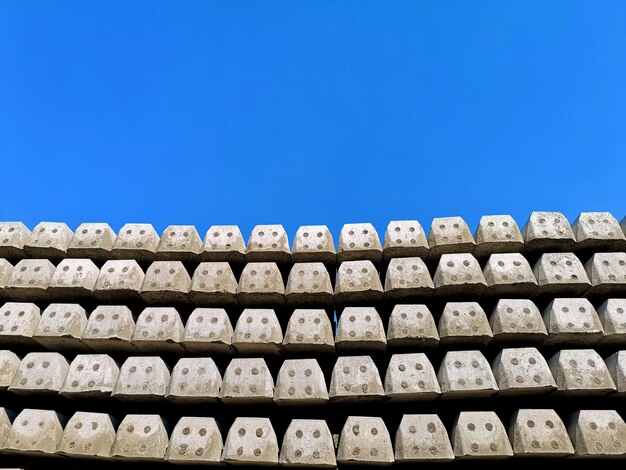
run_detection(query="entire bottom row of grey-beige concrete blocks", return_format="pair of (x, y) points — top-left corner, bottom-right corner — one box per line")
(0, 408), (626, 462)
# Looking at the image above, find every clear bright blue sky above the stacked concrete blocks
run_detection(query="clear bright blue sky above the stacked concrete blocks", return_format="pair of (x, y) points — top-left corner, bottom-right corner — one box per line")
(0, 0), (626, 241)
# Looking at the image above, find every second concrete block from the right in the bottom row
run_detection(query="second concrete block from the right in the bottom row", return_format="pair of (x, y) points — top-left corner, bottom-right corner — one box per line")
(509, 409), (574, 457)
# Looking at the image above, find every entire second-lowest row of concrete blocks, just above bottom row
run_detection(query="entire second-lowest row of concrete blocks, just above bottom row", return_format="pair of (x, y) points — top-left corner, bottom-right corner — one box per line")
(0, 347), (626, 405)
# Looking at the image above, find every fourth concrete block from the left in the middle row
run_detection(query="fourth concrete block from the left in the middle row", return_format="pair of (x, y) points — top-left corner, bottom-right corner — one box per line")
(131, 307), (185, 352)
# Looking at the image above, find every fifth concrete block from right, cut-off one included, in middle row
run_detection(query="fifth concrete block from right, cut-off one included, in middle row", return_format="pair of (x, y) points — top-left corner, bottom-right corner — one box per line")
(387, 304), (439, 349)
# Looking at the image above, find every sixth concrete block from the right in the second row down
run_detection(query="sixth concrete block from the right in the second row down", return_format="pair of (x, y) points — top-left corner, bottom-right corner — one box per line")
(335, 260), (383, 304)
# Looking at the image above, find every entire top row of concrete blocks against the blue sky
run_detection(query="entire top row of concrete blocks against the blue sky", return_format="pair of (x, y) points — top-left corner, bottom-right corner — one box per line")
(0, 212), (626, 264)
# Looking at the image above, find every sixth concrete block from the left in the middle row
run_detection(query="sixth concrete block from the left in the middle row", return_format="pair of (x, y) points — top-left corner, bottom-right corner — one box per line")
(233, 308), (283, 354)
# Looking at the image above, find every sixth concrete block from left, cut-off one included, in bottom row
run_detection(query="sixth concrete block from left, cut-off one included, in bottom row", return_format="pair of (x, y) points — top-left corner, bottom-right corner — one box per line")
(222, 418), (278, 465)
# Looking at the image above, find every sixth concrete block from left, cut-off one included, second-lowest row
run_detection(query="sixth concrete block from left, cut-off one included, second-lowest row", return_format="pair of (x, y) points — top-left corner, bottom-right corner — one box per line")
(220, 357), (274, 405)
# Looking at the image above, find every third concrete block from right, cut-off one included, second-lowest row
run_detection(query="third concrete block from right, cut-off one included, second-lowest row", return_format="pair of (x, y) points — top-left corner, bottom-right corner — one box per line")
(491, 348), (556, 395)
